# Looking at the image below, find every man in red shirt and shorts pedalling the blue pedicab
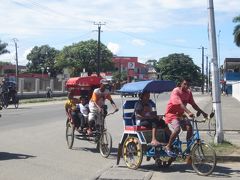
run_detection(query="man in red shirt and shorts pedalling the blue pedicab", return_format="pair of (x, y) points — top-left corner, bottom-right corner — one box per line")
(165, 79), (208, 157)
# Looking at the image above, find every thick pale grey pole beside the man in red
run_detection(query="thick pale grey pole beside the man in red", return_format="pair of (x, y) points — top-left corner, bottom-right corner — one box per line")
(208, 0), (224, 143)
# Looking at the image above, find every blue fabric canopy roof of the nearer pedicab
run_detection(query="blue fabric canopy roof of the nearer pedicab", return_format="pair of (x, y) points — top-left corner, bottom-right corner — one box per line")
(118, 80), (176, 94)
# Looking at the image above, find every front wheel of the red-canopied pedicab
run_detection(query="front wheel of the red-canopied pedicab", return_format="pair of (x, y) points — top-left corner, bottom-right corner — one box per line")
(98, 131), (112, 158)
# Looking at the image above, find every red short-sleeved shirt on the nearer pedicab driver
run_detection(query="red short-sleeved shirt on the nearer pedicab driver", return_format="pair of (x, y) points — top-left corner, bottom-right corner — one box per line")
(165, 87), (195, 123)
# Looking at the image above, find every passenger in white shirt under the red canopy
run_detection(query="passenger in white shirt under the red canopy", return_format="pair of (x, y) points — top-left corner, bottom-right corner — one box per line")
(77, 96), (89, 131)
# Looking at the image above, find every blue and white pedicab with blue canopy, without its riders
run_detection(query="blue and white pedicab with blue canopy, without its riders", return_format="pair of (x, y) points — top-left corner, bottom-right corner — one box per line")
(117, 80), (216, 176)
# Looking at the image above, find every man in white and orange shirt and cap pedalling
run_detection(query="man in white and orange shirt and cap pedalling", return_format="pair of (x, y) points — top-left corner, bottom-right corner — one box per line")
(88, 79), (118, 134)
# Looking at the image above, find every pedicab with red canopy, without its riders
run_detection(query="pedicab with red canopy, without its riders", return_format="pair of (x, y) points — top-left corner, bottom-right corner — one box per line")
(66, 76), (115, 158)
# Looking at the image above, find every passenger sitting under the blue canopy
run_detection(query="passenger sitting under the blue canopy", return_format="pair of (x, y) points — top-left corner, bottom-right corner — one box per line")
(134, 92), (171, 146)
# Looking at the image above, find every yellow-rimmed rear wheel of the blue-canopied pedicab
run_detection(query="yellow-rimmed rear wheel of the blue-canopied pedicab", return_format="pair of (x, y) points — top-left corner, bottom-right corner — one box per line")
(122, 136), (143, 169)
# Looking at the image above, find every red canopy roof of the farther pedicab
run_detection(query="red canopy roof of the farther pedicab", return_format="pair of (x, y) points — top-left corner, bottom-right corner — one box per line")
(66, 76), (102, 88)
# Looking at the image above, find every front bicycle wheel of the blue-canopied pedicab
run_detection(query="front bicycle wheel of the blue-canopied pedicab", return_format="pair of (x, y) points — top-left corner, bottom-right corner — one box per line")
(191, 143), (216, 176)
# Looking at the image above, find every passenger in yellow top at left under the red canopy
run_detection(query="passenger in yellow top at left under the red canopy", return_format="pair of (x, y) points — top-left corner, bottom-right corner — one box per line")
(64, 92), (81, 128)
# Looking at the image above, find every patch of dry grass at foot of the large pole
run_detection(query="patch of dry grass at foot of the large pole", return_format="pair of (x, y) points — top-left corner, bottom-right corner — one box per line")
(211, 140), (240, 155)
